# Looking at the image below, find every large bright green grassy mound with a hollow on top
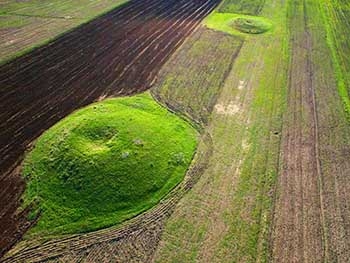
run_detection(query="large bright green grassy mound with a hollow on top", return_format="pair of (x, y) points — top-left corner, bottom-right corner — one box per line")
(23, 94), (197, 239)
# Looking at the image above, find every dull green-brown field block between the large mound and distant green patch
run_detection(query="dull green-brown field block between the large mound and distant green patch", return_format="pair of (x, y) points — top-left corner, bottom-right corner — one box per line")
(152, 28), (242, 125)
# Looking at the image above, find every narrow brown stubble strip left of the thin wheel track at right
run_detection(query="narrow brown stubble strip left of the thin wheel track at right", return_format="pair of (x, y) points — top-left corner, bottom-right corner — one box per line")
(273, 1), (324, 262)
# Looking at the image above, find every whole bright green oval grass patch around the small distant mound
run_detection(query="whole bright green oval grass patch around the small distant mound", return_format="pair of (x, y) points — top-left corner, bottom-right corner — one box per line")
(204, 12), (272, 36)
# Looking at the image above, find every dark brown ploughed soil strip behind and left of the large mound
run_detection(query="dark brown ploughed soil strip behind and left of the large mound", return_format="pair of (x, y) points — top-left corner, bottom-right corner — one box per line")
(0, 0), (219, 257)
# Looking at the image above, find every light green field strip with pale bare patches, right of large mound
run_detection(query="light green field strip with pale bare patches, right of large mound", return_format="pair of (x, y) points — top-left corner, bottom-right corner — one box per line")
(155, 1), (288, 262)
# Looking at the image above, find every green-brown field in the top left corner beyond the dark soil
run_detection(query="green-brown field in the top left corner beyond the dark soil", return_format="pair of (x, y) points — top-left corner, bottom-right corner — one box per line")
(0, 0), (128, 65)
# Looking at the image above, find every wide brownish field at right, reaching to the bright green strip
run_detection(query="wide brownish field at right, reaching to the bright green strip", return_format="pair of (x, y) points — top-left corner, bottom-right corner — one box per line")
(272, 1), (350, 262)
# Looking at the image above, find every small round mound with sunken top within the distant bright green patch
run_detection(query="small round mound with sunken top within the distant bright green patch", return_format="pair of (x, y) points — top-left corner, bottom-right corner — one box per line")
(232, 17), (271, 34)
